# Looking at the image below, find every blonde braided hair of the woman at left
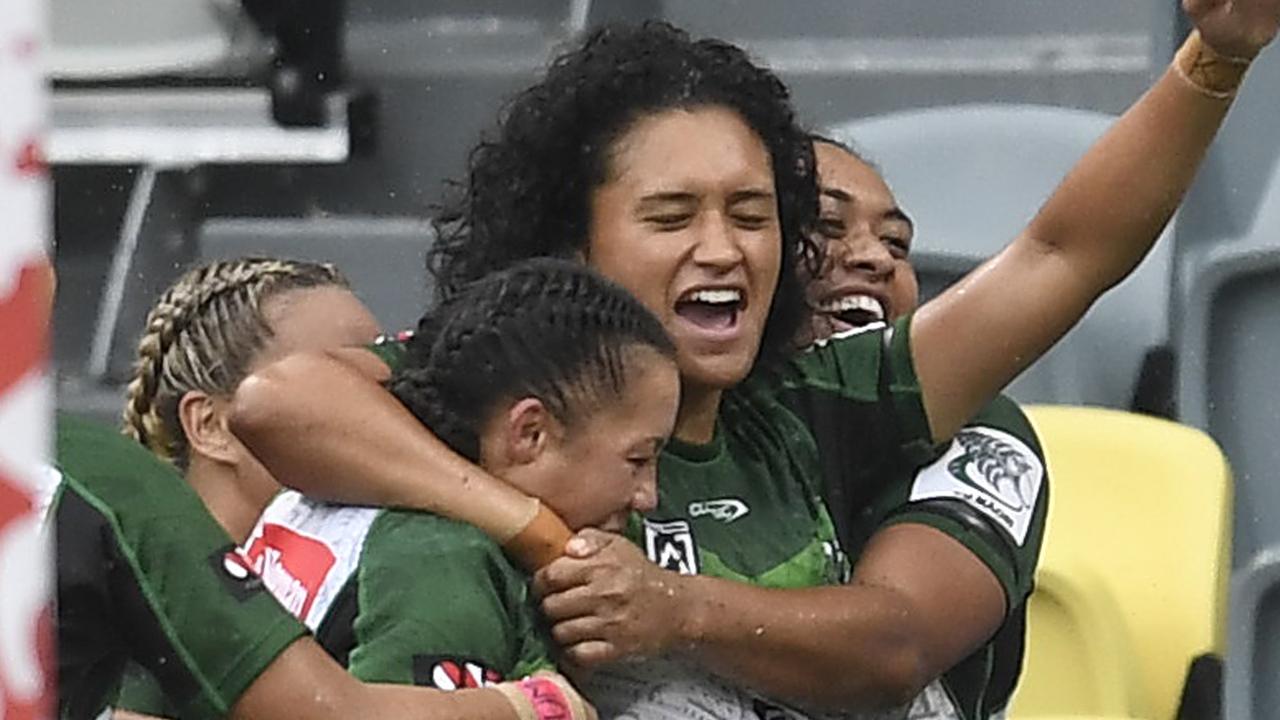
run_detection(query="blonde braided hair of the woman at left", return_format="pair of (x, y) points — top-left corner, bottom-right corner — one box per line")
(124, 258), (348, 468)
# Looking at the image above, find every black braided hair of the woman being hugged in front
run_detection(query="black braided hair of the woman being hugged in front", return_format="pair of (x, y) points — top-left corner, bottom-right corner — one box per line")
(388, 259), (676, 461)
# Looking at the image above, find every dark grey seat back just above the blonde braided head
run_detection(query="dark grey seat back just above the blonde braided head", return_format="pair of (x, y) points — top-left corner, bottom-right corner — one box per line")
(197, 217), (433, 332)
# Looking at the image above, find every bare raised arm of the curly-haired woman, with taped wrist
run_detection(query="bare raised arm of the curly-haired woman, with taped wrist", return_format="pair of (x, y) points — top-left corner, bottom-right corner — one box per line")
(911, 0), (1280, 439)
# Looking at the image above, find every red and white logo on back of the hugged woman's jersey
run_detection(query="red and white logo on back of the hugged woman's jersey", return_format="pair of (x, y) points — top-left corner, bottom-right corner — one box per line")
(244, 523), (335, 620)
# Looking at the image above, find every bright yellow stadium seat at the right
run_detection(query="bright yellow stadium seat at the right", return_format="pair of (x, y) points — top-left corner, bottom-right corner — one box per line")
(1010, 405), (1231, 720)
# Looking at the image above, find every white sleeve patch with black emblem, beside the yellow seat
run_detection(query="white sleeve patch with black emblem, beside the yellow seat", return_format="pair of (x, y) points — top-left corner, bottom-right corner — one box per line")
(910, 425), (1044, 544)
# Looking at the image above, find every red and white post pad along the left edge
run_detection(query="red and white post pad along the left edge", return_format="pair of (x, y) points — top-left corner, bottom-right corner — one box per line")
(0, 0), (55, 720)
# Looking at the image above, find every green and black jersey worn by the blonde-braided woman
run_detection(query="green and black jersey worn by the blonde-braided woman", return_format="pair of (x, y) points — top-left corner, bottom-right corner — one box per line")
(51, 416), (306, 717)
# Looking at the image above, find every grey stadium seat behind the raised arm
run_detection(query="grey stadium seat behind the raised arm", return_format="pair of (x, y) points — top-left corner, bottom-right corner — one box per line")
(831, 105), (1171, 409)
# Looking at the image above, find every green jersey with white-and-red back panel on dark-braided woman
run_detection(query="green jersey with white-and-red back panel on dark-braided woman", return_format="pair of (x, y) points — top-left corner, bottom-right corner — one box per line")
(244, 492), (554, 689)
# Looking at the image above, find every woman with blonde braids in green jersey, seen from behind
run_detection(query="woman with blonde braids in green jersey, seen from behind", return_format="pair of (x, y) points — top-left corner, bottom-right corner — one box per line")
(51, 259), (593, 720)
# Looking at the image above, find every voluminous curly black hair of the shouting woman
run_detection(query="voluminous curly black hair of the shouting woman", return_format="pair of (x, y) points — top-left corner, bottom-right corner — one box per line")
(428, 22), (820, 368)
